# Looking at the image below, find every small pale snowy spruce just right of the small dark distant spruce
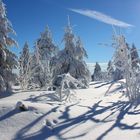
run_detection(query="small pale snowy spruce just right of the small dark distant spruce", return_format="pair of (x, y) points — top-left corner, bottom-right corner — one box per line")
(107, 60), (114, 81)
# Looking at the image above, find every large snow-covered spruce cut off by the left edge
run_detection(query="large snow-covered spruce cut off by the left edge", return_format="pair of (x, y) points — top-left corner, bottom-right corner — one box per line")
(0, 0), (17, 92)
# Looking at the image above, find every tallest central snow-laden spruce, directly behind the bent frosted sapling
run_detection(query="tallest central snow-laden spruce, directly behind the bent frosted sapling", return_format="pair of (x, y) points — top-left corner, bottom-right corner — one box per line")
(53, 18), (90, 88)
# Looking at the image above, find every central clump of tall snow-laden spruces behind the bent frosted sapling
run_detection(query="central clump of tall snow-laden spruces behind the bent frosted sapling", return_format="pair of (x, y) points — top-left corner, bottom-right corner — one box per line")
(19, 18), (90, 93)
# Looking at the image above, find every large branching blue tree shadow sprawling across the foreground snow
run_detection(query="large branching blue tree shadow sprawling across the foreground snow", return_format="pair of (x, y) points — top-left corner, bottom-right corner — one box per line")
(14, 100), (140, 140)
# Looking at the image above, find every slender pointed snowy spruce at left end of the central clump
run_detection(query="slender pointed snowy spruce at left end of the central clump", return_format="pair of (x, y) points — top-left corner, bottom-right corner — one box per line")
(19, 42), (30, 90)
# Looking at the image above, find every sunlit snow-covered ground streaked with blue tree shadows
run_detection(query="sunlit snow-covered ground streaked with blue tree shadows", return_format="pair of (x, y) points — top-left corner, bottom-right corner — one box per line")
(0, 82), (140, 140)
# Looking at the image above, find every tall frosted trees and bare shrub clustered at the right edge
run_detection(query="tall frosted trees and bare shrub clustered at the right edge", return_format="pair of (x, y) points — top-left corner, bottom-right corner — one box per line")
(106, 35), (140, 103)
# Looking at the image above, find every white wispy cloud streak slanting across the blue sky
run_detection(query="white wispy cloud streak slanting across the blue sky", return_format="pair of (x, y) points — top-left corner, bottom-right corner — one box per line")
(69, 9), (134, 28)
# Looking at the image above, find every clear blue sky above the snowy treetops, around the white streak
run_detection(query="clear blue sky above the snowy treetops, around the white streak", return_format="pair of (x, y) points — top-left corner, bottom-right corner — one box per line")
(3, 0), (140, 62)
